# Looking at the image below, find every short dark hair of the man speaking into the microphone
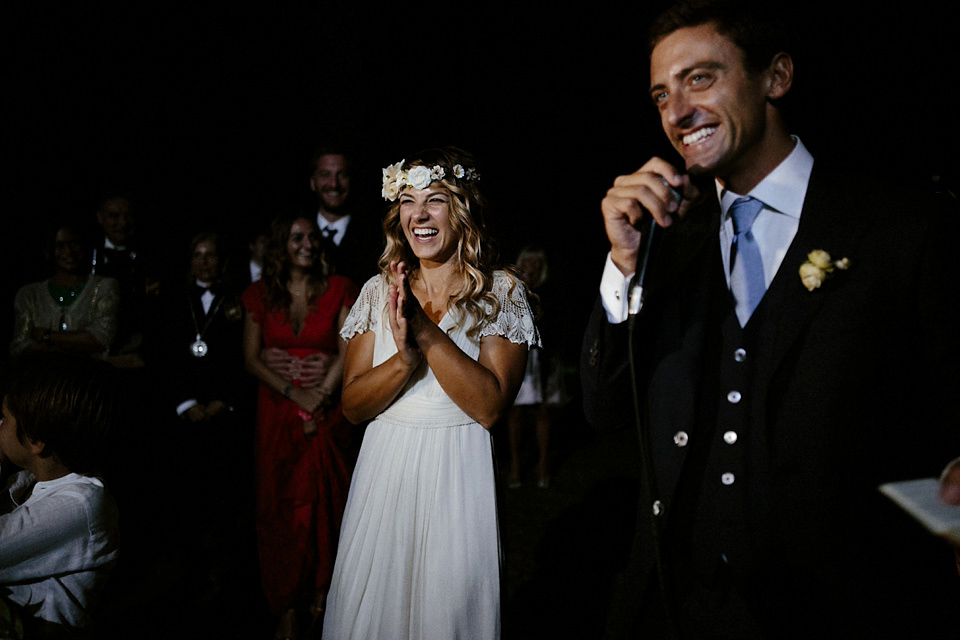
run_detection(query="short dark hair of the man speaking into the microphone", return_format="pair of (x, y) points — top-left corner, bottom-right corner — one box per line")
(647, 0), (795, 73)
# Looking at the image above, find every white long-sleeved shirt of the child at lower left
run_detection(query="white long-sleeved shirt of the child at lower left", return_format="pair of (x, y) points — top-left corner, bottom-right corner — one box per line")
(0, 471), (117, 627)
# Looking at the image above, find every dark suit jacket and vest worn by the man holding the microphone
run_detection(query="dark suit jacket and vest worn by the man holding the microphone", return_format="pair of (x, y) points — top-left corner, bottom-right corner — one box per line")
(581, 165), (960, 637)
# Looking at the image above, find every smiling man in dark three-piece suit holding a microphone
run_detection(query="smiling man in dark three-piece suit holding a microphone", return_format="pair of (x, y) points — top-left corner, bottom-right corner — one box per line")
(582, 2), (960, 639)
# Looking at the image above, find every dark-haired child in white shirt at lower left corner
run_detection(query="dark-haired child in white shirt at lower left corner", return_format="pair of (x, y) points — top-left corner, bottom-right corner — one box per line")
(0, 355), (117, 637)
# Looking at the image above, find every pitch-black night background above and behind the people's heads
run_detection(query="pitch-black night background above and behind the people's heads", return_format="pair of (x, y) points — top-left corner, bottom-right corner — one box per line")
(0, 0), (960, 318)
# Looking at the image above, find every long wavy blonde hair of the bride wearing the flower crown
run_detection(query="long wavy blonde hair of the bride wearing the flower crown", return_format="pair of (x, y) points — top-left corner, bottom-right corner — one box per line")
(379, 147), (519, 338)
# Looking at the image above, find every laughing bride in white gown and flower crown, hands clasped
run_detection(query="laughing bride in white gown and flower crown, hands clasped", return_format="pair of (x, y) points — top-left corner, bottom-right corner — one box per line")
(323, 149), (539, 640)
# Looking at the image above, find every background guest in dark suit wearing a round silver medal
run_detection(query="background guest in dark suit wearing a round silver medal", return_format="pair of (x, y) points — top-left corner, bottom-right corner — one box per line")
(161, 231), (255, 624)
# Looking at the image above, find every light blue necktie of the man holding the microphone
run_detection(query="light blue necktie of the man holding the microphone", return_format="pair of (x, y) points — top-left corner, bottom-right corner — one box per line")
(730, 198), (767, 326)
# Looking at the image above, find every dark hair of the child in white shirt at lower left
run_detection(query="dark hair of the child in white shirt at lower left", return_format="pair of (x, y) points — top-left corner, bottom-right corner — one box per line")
(5, 353), (117, 474)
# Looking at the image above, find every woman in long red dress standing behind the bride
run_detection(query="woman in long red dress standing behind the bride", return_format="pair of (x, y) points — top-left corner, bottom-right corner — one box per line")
(243, 212), (357, 638)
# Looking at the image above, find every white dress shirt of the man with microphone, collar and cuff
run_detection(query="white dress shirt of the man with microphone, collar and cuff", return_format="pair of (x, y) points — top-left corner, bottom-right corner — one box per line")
(600, 137), (813, 323)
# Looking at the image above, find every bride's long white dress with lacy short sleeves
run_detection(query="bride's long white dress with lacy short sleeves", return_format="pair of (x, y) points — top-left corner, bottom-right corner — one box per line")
(323, 272), (539, 640)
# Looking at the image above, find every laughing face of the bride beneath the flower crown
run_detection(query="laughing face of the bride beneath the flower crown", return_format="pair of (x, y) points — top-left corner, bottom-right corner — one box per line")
(400, 182), (459, 264)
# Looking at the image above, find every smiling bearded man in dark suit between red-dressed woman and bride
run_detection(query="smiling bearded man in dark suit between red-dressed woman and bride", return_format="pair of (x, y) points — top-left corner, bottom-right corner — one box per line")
(310, 146), (384, 286)
